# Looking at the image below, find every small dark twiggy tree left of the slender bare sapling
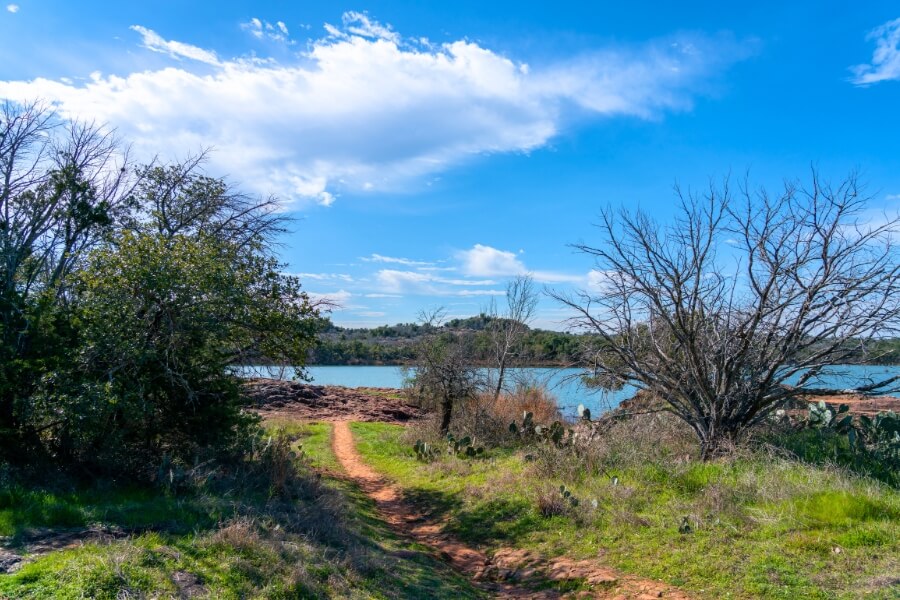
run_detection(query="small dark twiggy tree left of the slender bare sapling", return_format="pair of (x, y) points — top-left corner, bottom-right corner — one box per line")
(413, 309), (480, 435)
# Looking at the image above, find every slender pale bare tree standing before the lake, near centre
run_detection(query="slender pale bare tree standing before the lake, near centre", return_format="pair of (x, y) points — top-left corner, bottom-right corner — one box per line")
(488, 275), (538, 402)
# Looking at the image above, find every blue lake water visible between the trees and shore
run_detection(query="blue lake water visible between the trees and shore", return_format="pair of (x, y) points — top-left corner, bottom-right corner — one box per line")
(242, 365), (900, 417)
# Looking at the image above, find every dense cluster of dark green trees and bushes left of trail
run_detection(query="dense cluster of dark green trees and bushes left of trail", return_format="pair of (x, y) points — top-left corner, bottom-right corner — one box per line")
(0, 105), (318, 479)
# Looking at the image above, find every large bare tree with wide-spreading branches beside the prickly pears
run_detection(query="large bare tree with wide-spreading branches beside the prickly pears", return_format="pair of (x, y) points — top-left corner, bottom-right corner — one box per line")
(557, 172), (900, 458)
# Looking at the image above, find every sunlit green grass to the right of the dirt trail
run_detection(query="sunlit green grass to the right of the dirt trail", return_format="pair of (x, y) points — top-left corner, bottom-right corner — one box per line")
(352, 423), (900, 599)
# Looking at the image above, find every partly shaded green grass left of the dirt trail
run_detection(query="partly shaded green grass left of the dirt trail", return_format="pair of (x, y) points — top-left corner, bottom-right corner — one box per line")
(0, 423), (481, 599)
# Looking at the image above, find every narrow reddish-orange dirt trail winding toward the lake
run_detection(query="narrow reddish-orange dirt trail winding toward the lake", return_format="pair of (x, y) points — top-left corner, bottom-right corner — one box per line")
(332, 421), (689, 600)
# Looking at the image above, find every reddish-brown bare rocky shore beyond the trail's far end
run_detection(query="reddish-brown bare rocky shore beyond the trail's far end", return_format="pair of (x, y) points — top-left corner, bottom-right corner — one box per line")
(244, 378), (424, 423)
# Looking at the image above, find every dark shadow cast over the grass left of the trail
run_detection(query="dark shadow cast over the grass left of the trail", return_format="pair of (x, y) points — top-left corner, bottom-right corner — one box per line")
(0, 458), (484, 600)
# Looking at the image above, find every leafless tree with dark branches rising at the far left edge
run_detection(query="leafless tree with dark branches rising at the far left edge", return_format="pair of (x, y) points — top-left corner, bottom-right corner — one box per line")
(0, 102), (134, 302)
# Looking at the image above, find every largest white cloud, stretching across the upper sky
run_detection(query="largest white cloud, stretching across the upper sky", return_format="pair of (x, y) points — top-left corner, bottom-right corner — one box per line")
(0, 13), (737, 205)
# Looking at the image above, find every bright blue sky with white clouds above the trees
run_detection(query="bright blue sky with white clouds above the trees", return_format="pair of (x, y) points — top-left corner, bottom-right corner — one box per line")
(0, 0), (900, 329)
